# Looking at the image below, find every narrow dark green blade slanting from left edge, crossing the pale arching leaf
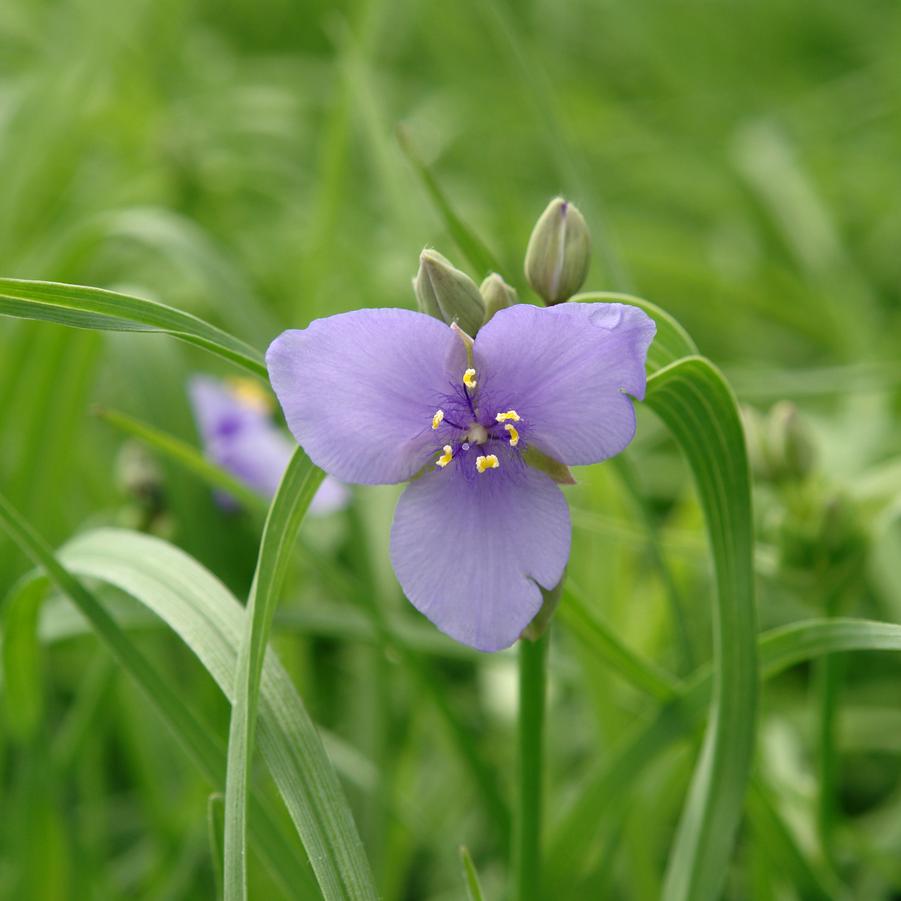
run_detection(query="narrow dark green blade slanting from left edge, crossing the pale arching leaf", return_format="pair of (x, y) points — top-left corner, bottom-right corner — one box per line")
(0, 495), (315, 897)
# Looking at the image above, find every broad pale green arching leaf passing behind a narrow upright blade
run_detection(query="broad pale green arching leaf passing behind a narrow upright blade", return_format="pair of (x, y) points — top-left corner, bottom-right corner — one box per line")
(51, 529), (375, 899)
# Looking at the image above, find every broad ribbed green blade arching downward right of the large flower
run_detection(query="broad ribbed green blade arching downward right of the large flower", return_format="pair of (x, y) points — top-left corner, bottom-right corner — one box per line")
(646, 357), (758, 901)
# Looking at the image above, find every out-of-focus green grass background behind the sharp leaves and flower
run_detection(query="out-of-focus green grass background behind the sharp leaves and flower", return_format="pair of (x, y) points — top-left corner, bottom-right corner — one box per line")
(0, 0), (901, 899)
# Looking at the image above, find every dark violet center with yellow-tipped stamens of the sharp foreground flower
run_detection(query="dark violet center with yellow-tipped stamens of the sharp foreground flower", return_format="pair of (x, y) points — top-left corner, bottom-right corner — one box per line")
(431, 367), (524, 475)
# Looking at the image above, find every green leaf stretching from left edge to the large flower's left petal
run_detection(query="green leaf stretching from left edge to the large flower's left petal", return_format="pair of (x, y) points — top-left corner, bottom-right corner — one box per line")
(0, 278), (267, 378)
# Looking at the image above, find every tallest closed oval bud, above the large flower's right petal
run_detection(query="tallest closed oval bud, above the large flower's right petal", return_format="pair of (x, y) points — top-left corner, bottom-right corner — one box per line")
(526, 197), (591, 306)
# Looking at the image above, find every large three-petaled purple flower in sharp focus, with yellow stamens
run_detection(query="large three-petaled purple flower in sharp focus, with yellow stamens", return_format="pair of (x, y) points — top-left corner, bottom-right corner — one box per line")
(266, 303), (655, 651)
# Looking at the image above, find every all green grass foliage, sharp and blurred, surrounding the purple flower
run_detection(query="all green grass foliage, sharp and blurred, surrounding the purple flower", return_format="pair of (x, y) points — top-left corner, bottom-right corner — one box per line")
(0, 0), (901, 901)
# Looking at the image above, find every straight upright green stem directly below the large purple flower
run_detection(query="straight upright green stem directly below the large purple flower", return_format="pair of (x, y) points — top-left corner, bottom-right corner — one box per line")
(513, 631), (548, 901)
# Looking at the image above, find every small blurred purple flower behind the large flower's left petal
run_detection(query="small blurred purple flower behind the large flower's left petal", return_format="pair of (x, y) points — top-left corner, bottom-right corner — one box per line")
(188, 375), (348, 515)
